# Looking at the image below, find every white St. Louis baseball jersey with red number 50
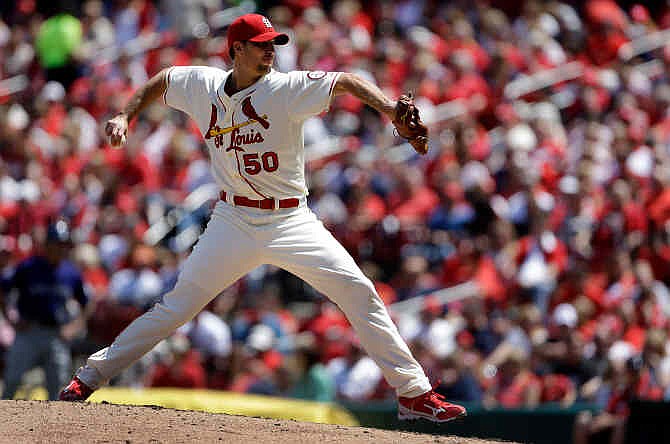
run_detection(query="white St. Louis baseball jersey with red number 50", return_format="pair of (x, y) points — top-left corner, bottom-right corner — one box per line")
(164, 66), (340, 199)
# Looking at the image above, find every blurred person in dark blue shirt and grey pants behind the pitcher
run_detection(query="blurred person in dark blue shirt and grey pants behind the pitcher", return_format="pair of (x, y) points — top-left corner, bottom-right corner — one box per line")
(0, 220), (88, 400)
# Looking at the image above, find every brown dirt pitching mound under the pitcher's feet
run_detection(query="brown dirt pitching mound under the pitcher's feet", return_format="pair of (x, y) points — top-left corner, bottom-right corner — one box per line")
(0, 401), (520, 444)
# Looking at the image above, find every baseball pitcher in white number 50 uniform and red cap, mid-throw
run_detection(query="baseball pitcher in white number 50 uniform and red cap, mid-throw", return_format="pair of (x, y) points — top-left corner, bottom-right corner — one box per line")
(60, 14), (466, 422)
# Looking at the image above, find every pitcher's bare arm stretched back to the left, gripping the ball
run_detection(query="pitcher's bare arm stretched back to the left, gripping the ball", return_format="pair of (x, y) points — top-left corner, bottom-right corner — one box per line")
(105, 69), (167, 146)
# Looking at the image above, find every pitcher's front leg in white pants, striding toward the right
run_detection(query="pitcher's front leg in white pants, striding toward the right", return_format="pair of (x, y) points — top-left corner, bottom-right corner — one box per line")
(266, 213), (431, 397)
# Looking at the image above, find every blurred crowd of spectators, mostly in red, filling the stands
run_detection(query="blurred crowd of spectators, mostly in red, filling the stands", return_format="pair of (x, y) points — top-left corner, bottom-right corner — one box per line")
(0, 0), (670, 426)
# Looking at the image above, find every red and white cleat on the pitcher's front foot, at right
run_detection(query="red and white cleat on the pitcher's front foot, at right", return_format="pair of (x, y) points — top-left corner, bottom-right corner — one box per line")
(398, 390), (467, 422)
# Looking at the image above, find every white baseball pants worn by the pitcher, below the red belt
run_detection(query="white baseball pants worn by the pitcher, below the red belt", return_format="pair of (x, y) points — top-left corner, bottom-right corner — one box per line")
(78, 201), (431, 397)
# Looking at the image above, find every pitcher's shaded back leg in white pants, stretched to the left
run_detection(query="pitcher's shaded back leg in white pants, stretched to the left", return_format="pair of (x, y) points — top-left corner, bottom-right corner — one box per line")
(77, 212), (260, 389)
